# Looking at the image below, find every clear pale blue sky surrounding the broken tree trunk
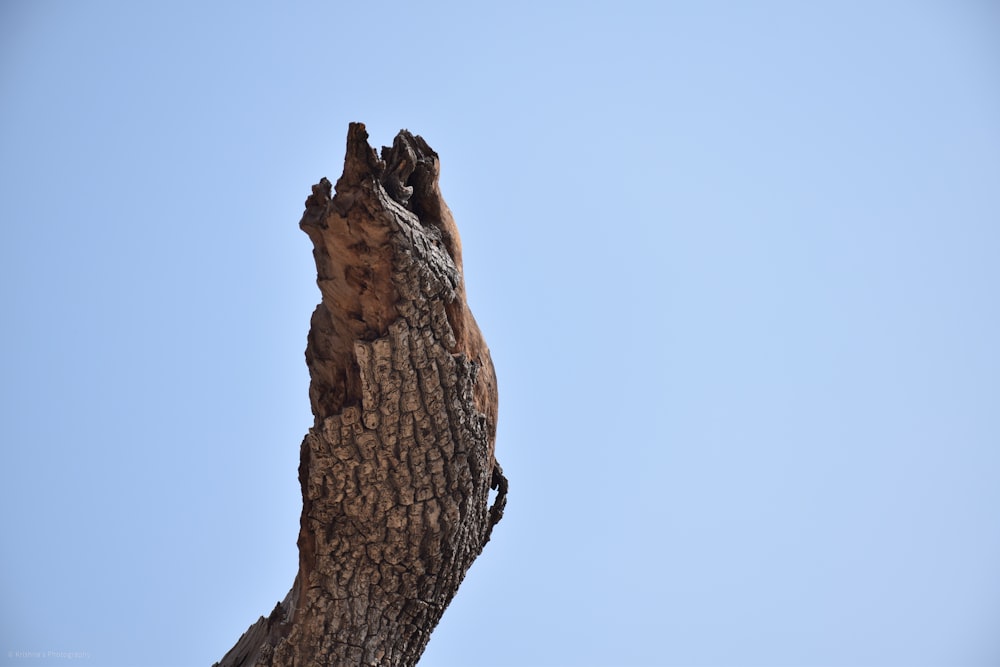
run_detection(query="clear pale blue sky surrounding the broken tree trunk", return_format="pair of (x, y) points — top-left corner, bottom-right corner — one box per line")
(0, 0), (1000, 667)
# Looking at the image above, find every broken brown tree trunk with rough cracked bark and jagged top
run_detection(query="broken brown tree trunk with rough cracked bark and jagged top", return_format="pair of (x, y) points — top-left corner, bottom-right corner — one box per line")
(217, 123), (507, 667)
